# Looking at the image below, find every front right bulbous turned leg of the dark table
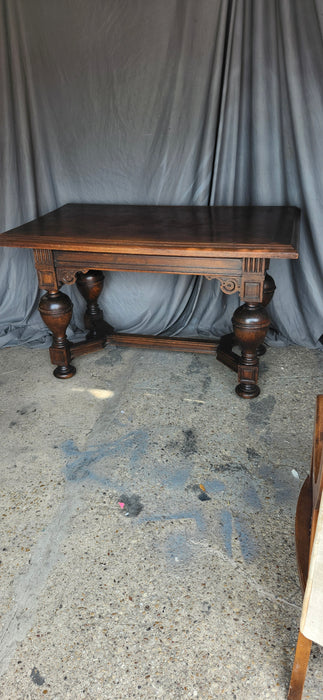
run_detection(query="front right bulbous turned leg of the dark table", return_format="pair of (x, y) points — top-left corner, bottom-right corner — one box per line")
(232, 303), (270, 399)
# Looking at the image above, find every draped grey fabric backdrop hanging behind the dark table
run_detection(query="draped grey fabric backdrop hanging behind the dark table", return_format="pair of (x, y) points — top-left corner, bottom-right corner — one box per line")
(0, 0), (323, 347)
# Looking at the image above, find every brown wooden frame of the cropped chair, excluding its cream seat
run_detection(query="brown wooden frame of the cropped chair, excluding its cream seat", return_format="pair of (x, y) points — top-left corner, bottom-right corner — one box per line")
(288, 394), (323, 700)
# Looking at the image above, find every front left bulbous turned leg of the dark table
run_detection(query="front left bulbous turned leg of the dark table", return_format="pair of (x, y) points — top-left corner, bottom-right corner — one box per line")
(39, 291), (76, 379)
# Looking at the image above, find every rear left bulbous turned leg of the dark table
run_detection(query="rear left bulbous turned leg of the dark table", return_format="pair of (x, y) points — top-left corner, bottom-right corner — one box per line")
(76, 270), (113, 340)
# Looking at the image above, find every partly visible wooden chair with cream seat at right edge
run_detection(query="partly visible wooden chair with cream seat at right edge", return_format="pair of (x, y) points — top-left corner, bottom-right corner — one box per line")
(288, 394), (323, 700)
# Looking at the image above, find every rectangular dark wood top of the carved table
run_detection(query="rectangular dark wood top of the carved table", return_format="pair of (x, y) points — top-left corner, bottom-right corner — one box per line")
(0, 204), (300, 258)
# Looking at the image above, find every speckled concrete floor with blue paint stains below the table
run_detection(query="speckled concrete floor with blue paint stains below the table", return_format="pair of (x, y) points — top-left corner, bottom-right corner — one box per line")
(0, 347), (323, 700)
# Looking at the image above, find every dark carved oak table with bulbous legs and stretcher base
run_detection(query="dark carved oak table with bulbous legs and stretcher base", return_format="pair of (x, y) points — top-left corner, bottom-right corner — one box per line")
(0, 204), (300, 398)
